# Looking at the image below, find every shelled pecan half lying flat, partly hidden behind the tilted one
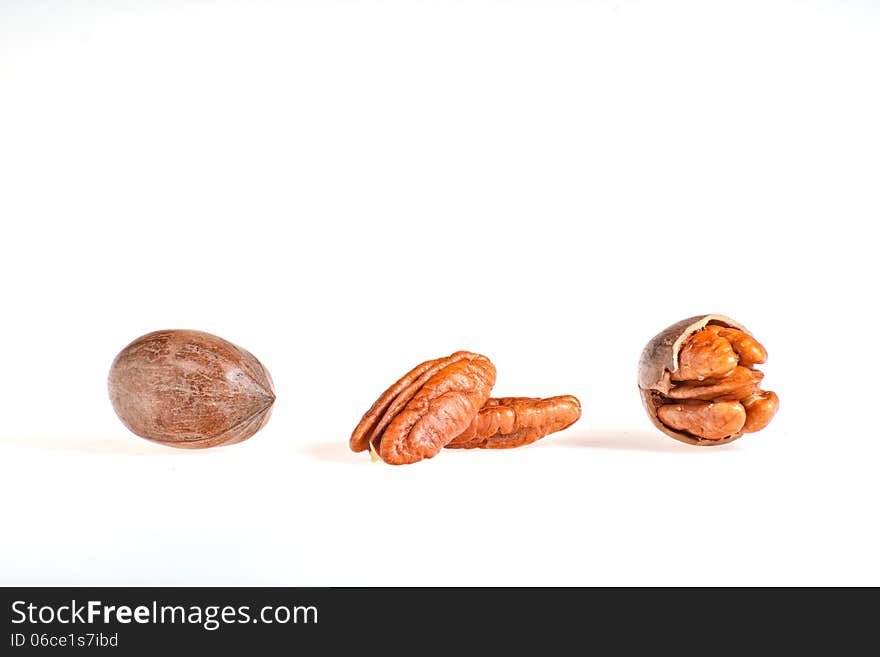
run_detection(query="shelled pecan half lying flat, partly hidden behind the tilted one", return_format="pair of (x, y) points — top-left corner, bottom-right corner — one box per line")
(446, 395), (581, 449)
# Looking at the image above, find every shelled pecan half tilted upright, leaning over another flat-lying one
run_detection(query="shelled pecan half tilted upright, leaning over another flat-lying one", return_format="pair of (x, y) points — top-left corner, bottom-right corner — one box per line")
(349, 351), (495, 465)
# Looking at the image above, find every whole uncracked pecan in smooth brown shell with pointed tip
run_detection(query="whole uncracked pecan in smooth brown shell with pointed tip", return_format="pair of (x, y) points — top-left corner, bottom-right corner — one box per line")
(107, 330), (275, 449)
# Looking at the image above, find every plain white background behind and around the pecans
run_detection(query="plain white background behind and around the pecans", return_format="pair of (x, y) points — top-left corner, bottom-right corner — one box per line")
(0, 0), (880, 585)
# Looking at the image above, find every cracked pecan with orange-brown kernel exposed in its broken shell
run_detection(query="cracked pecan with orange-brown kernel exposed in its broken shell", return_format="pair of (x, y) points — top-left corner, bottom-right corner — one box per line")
(639, 315), (779, 445)
